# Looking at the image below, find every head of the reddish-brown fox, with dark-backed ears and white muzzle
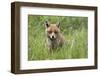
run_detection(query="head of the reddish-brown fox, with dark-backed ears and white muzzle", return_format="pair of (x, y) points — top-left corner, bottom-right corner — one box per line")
(45, 21), (60, 40)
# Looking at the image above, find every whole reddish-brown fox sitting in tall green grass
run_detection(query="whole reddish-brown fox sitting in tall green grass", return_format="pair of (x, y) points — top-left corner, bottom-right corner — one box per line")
(45, 21), (65, 51)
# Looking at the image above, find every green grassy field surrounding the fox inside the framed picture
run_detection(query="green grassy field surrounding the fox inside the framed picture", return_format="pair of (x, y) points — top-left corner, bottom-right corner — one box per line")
(28, 15), (88, 60)
